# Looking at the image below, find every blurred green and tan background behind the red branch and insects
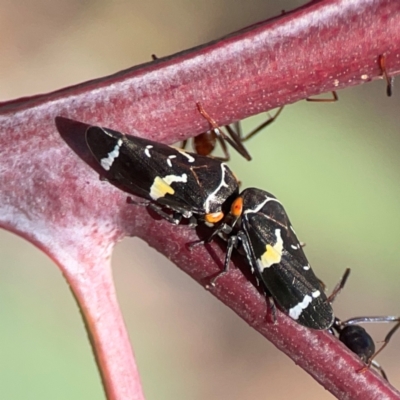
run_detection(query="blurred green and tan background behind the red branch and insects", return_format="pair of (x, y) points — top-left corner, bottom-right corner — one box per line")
(0, 0), (400, 400)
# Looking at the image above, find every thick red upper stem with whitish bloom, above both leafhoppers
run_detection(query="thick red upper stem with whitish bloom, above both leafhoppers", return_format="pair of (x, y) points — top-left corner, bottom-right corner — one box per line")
(0, 0), (400, 142)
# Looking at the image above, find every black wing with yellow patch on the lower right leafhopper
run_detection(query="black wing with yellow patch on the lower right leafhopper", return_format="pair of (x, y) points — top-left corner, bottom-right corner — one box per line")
(242, 189), (334, 330)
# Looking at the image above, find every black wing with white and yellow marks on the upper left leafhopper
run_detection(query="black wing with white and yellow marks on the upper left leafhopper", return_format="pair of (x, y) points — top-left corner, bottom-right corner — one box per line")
(86, 127), (238, 215)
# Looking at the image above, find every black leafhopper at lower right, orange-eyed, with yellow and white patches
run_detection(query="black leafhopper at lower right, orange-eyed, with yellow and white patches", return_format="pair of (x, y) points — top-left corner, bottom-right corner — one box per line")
(203, 188), (334, 330)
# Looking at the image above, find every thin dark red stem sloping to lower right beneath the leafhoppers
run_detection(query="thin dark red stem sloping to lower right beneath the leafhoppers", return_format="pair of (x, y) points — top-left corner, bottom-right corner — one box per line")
(139, 221), (400, 400)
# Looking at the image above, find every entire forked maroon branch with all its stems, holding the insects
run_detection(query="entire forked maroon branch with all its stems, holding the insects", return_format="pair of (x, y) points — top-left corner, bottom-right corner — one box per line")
(0, 0), (400, 400)
